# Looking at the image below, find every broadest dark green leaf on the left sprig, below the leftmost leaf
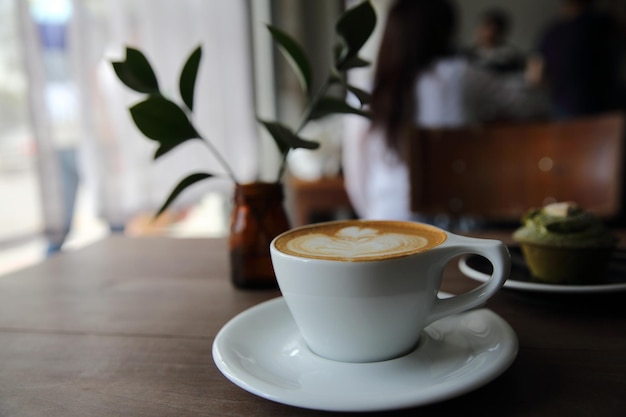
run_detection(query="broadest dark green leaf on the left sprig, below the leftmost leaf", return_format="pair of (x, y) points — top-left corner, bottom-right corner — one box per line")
(130, 96), (199, 158)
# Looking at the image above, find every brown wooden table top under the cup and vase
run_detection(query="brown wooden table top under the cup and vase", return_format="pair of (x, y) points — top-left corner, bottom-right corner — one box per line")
(0, 237), (626, 417)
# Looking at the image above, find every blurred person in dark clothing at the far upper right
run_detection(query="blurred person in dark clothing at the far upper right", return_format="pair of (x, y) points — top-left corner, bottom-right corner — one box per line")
(538, 0), (622, 118)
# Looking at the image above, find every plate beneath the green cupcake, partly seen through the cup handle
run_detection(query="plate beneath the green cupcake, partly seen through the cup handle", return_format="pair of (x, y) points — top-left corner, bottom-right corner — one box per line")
(459, 247), (626, 294)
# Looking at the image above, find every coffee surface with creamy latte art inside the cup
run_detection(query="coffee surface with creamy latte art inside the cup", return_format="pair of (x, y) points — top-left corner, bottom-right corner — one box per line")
(275, 220), (446, 262)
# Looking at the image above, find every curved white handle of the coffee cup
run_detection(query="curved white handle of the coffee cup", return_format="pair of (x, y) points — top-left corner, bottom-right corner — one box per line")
(426, 233), (511, 324)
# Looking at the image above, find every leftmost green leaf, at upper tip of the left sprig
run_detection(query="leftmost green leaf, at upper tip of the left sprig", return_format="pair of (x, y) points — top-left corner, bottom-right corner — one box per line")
(112, 47), (159, 94)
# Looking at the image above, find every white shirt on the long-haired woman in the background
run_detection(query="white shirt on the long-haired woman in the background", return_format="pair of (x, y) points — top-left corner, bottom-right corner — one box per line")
(343, 58), (548, 220)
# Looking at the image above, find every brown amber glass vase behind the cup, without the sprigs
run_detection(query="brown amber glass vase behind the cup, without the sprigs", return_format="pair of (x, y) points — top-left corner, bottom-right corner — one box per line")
(230, 182), (289, 288)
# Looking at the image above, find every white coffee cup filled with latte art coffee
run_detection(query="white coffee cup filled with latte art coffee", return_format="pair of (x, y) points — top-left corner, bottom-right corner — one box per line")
(270, 220), (510, 362)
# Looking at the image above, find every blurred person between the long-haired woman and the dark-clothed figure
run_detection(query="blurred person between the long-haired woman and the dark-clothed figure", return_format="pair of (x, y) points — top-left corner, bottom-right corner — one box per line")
(460, 9), (526, 73)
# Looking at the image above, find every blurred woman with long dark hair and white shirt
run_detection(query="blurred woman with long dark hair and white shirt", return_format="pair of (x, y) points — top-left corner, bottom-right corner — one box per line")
(343, 0), (546, 220)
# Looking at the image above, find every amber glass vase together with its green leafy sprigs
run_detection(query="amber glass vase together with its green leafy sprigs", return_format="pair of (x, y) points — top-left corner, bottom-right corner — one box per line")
(112, 1), (376, 287)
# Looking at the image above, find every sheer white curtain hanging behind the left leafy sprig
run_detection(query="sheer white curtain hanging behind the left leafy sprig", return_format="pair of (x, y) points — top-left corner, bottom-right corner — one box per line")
(15, 0), (259, 234)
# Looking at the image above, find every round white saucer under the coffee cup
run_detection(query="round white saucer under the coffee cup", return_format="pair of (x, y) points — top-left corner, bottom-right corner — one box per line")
(213, 298), (518, 411)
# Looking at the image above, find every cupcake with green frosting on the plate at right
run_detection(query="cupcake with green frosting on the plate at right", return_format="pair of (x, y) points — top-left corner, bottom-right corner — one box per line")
(513, 202), (617, 284)
